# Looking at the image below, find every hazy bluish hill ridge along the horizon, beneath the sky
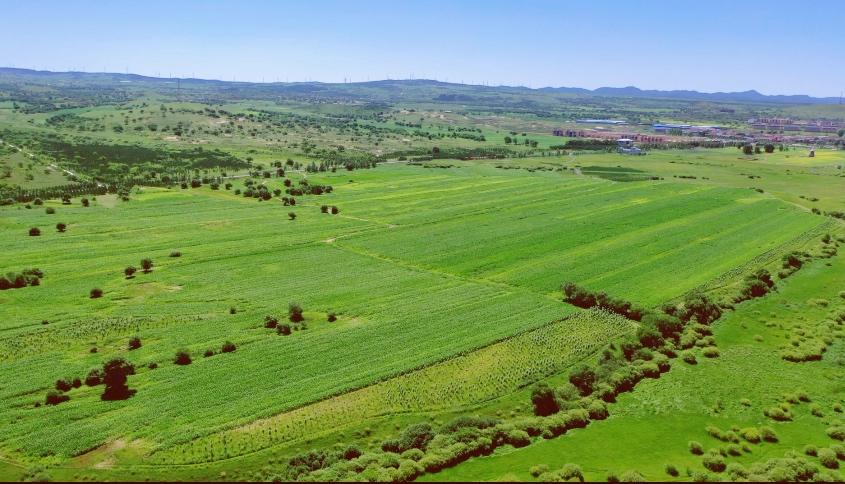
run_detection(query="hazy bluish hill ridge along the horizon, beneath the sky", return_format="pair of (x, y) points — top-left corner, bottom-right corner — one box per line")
(0, 67), (840, 104)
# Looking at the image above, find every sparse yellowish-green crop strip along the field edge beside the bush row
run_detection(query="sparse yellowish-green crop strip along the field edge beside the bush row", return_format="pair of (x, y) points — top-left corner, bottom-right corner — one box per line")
(153, 310), (636, 464)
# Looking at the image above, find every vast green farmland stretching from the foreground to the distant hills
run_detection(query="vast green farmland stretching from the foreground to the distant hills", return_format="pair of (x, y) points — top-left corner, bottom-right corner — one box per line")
(0, 70), (845, 480)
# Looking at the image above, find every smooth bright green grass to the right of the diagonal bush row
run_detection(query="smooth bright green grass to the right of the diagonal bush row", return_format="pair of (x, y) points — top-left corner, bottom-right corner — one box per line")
(423, 253), (845, 481)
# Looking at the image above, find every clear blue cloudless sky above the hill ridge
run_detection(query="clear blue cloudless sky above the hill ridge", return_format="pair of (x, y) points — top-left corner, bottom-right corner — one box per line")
(0, 0), (845, 96)
